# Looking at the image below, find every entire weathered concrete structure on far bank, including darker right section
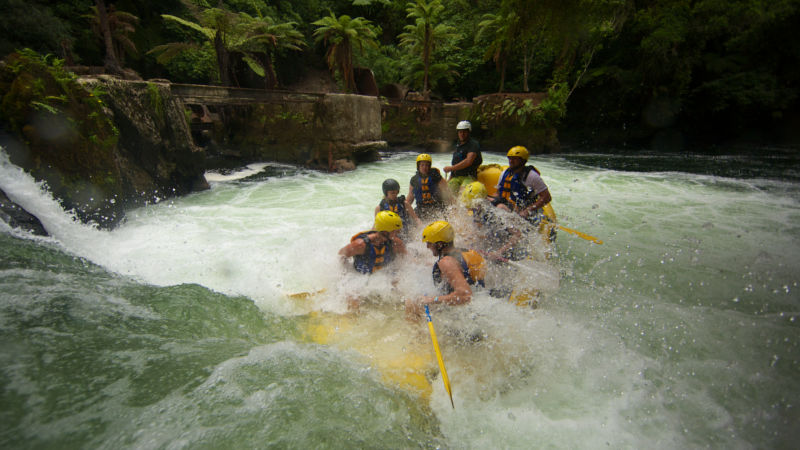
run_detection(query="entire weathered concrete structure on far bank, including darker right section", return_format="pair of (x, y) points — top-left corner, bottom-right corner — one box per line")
(170, 84), (472, 169)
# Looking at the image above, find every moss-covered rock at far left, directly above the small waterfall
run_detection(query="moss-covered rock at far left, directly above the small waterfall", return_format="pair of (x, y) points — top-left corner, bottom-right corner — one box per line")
(0, 51), (122, 225)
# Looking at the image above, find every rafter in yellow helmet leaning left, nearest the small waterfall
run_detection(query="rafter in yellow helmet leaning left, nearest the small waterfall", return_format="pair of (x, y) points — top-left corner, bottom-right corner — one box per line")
(339, 211), (406, 274)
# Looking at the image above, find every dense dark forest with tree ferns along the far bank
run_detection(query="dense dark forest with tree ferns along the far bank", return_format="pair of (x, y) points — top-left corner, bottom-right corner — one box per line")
(0, 0), (800, 149)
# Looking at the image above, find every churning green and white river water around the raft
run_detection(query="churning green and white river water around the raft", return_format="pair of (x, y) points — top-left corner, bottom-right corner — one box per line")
(0, 149), (800, 449)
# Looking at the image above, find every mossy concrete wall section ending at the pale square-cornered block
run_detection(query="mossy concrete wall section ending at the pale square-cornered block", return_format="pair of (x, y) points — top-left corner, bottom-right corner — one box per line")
(173, 85), (388, 170)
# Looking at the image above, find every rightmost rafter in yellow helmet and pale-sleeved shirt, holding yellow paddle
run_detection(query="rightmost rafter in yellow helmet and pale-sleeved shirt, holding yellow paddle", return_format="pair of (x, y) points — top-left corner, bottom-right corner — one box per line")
(490, 145), (552, 225)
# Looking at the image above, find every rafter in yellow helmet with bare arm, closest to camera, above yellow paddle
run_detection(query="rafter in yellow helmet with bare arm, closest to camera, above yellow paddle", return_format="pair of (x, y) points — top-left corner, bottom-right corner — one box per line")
(406, 220), (486, 319)
